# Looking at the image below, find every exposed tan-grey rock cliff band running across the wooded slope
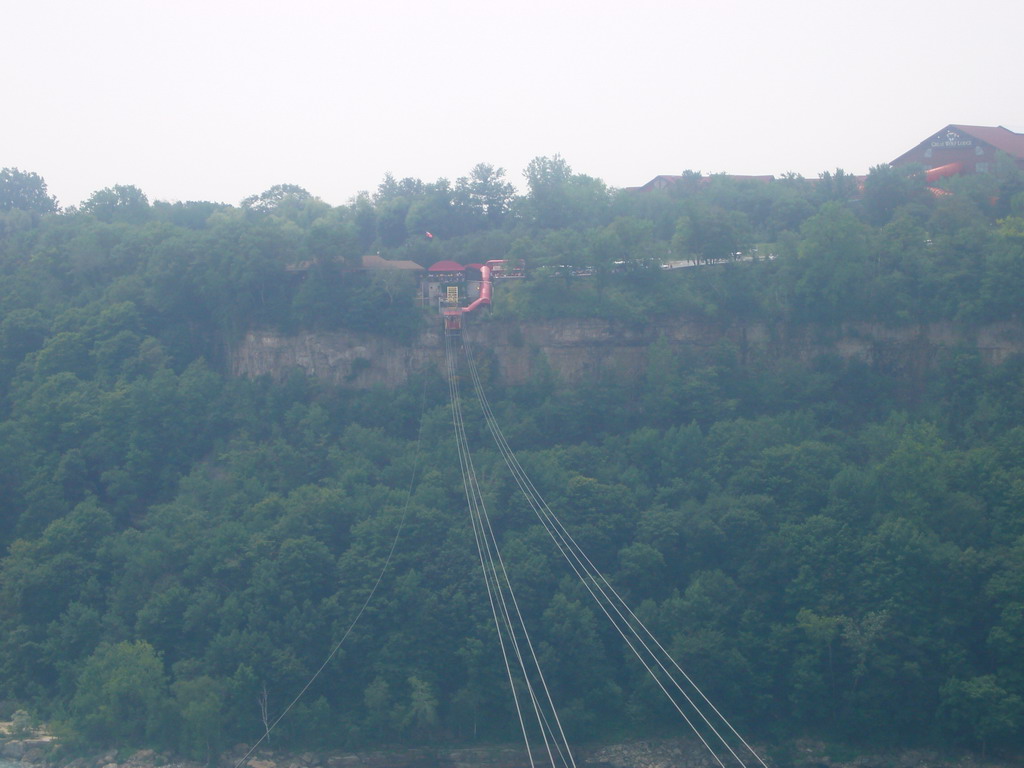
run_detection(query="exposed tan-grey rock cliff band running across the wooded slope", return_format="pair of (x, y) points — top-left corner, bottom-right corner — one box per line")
(231, 318), (1024, 389)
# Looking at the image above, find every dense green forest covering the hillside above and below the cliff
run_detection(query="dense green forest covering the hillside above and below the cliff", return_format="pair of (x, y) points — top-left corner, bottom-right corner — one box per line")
(0, 156), (1024, 761)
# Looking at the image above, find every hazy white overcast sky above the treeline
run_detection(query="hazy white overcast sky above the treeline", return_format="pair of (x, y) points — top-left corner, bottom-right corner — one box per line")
(8, 0), (1024, 205)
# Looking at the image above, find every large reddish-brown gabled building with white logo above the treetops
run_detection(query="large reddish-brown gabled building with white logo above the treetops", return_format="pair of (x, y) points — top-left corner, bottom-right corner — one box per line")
(890, 124), (1024, 173)
